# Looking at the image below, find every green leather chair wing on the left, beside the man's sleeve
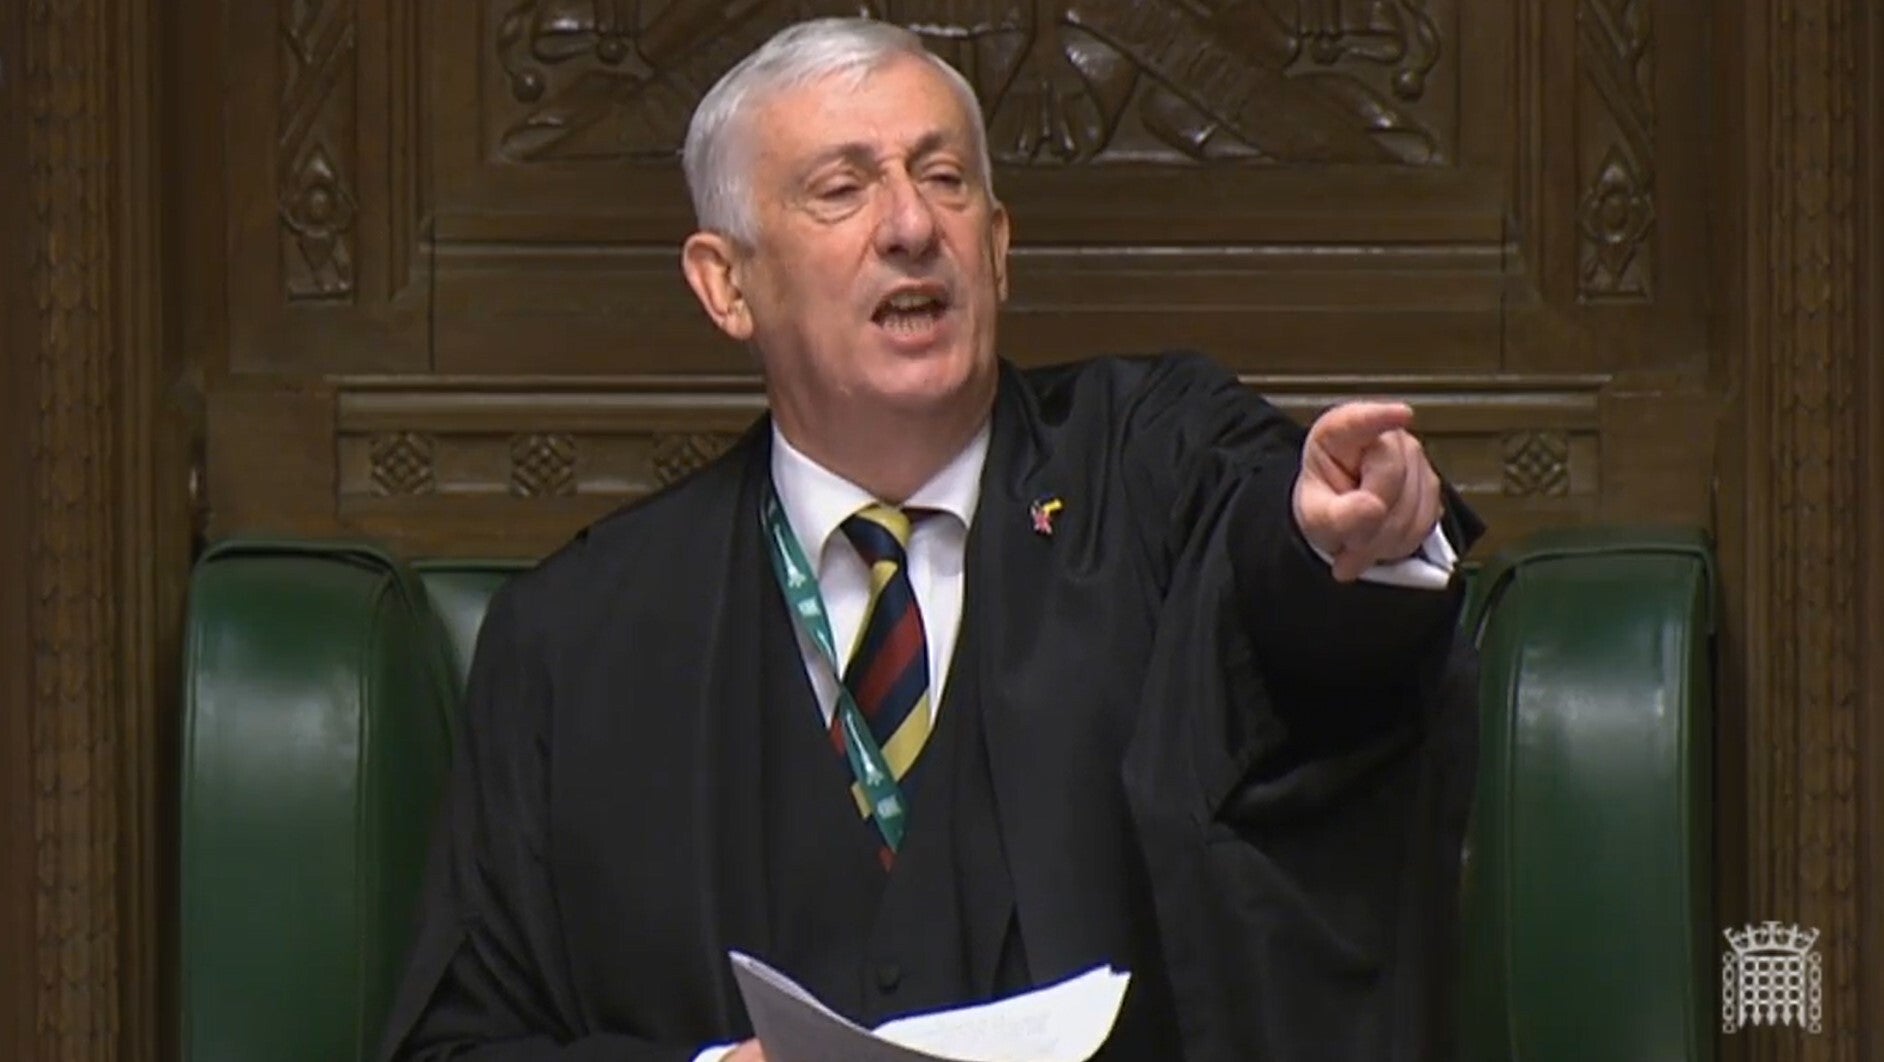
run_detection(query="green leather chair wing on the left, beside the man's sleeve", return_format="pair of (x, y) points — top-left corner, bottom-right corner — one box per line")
(179, 542), (471, 1062)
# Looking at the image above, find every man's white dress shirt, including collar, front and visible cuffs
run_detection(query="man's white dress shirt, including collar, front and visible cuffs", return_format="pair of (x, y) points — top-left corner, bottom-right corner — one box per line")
(693, 424), (1458, 1062)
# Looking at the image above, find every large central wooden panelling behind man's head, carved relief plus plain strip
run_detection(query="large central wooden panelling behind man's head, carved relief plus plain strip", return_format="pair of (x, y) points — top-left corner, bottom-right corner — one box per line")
(416, 0), (1511, 373)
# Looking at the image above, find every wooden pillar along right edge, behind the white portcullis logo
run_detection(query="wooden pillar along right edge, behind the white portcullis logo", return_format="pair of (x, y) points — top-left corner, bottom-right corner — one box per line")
(1716, 0), (1884, 1060)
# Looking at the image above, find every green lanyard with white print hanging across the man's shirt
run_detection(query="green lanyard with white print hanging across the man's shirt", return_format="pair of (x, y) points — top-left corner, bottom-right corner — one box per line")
(763, 490), (904, 851)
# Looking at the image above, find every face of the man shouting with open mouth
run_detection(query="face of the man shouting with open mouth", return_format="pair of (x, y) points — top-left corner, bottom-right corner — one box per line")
(722, 56), (1008, 429)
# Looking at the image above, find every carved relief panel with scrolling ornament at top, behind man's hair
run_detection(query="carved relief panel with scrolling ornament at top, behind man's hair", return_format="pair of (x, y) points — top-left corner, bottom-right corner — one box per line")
(484, 0), (1456, 166)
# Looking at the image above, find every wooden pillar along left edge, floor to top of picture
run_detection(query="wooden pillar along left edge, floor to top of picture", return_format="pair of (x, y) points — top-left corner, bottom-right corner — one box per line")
(0, 0), (176, 1062)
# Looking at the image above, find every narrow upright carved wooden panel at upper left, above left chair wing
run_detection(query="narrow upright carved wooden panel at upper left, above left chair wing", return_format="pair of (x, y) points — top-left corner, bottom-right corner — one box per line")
(211, 0), (430, 371)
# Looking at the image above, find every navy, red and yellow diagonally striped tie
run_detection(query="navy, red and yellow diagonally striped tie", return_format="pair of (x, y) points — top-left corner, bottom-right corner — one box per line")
(831, 505), (929, 798)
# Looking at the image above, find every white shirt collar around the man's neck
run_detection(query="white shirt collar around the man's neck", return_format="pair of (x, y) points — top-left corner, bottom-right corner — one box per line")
(772, 420), (993, 563)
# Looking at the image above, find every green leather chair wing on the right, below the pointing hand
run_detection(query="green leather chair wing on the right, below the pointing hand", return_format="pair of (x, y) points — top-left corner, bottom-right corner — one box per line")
(1460, 529), (1716, 1062)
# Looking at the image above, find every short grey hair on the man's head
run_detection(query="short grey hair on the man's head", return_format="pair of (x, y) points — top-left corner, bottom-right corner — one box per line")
(680, 19), (995, 247)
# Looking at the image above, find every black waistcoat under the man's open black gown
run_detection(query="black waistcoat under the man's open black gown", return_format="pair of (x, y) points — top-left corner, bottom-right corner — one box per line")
(761, 572), (1029, 1026)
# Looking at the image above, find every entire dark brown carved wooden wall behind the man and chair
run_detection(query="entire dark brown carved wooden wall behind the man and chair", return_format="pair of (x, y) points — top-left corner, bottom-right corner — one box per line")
(0, 0), (1884, 1058)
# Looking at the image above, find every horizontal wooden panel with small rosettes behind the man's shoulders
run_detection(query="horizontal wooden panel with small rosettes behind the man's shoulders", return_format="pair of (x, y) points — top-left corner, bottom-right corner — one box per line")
(198, 375), (1713, 555)
